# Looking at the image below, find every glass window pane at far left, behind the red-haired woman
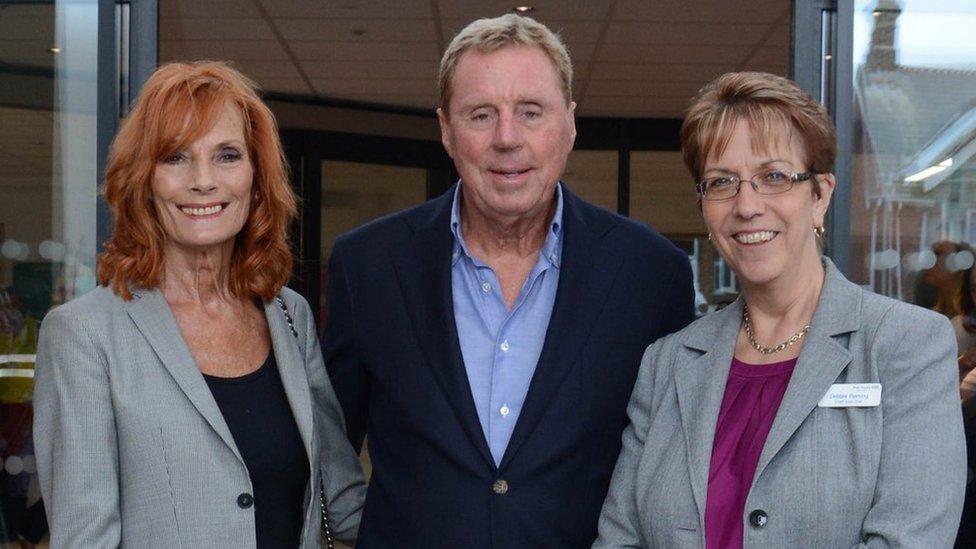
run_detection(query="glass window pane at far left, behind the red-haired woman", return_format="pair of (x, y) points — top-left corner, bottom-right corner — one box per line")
(0, 0), (98, 545)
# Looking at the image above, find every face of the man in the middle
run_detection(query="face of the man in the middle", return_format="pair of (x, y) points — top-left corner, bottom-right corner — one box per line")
(437, 46), (576, 222)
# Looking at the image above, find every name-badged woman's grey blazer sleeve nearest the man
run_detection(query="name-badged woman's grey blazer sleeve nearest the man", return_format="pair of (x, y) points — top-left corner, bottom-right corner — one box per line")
(593, 341), (662, 548)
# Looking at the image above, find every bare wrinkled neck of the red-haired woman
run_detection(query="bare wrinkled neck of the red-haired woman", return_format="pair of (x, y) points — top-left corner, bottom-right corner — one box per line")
(160, 240), (240, 306)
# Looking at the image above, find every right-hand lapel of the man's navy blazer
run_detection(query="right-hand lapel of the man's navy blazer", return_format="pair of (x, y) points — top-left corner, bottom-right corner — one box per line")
(499, 189), (622, 469)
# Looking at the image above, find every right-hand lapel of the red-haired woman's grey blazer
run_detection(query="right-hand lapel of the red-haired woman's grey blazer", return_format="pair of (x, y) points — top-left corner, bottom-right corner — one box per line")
(264, 299), (315, 467)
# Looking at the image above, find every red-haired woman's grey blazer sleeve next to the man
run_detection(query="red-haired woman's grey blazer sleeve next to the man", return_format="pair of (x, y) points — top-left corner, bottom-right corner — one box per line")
(299, 292), (366, 540)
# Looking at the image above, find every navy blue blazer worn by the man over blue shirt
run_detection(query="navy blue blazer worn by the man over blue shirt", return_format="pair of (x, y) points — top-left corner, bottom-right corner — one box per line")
(323, 186), (694, 549)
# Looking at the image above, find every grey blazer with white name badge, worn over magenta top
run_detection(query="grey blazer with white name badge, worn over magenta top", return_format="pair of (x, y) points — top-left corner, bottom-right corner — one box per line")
(594, 260), (966, 549)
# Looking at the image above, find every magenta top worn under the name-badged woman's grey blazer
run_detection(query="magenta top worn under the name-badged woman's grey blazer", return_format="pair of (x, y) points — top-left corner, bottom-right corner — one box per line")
(705, 358), (796, 549)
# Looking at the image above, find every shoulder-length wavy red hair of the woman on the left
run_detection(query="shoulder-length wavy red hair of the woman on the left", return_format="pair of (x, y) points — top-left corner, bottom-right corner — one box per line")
(98, 61), (297, 301)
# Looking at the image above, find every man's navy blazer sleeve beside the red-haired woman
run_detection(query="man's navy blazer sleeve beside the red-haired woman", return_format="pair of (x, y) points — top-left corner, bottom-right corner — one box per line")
(322, 237), (369, 452)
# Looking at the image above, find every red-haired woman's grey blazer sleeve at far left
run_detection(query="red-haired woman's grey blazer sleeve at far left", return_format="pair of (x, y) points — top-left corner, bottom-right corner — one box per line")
(34, 309), (122, 547)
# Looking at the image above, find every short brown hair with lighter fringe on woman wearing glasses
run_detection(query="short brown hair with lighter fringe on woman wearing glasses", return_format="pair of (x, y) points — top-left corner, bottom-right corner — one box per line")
(681, 72), (837, 182)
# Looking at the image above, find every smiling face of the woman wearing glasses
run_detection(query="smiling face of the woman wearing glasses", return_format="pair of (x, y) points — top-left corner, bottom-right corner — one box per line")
(702, 119), (834, 286)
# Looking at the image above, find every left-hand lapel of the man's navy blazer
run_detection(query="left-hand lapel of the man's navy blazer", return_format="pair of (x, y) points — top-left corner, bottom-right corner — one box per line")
(393, 187), (495, 469)
